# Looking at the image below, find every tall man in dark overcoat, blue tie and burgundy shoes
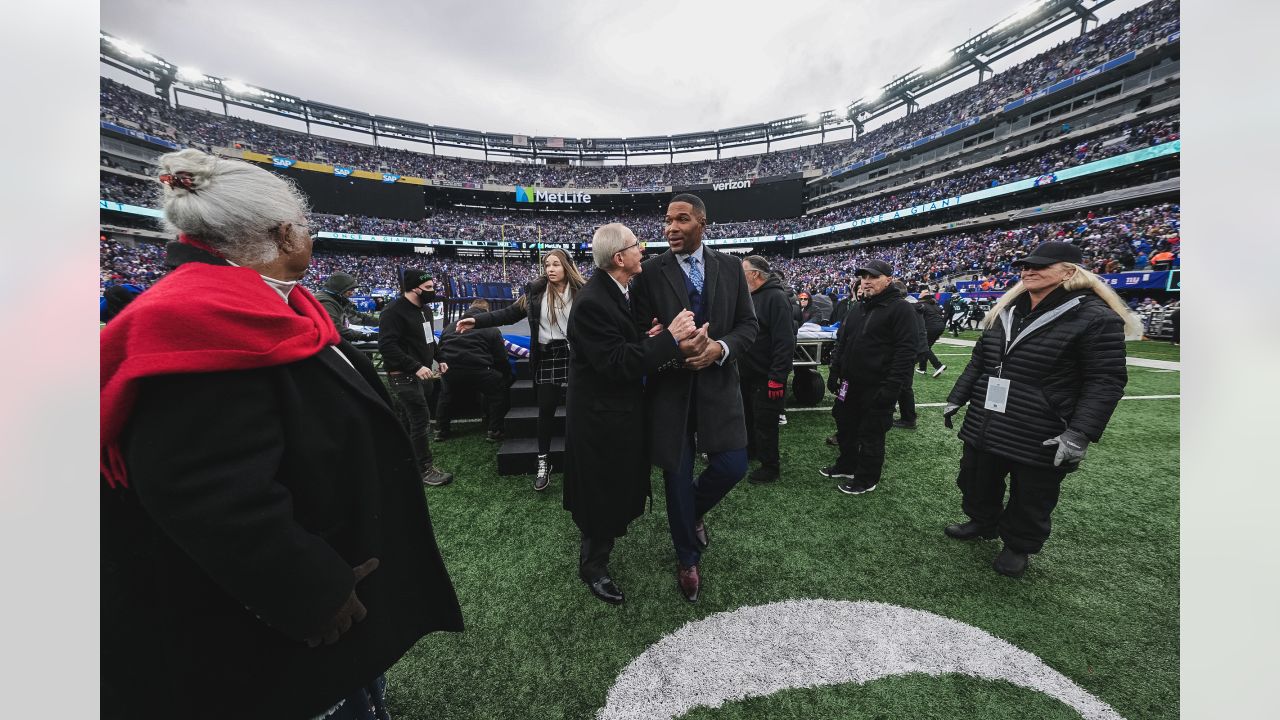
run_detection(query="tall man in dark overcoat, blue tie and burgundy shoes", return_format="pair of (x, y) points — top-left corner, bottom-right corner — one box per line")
(631, 193), (758, 602)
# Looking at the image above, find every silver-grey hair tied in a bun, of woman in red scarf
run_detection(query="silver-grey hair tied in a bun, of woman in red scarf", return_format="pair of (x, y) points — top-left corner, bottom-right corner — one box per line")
(160, 149), (307, 265)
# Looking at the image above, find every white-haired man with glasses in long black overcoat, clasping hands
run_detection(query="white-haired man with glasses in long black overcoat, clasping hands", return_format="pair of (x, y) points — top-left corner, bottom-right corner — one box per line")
(564, 223), (707, 605)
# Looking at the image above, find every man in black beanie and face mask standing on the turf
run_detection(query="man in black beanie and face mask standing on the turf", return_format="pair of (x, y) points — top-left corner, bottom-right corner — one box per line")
(378, 269), (453, 487)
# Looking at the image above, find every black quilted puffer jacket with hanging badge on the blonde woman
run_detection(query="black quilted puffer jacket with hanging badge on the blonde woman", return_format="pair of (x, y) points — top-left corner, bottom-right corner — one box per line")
(947, 288), (1129, 469)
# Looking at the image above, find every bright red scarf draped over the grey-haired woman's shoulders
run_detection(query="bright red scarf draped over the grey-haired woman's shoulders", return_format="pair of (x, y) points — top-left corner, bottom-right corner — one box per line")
(99, 257), (339, 488)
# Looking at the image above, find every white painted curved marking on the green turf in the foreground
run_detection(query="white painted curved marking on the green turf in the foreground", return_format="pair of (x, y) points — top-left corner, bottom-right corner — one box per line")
(596, 600), (1123, 720)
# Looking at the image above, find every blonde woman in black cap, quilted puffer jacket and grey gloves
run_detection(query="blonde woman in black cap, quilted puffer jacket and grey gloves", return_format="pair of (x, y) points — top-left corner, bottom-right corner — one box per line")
(943, 242), (1135, 578)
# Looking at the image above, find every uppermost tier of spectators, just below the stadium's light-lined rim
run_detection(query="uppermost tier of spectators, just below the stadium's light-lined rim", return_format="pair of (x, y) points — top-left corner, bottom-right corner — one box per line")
(100, 0), (1180, 187)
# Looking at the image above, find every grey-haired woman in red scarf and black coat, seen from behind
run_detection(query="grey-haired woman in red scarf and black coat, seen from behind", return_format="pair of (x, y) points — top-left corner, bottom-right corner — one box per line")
(101, 150), (462, 719)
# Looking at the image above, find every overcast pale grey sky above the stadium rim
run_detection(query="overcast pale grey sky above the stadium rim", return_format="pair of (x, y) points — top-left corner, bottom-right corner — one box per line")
(100, 0), (1142, 151)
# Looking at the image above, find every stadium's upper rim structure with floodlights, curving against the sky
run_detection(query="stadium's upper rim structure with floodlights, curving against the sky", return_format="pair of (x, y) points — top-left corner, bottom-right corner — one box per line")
(100, 0), (1114, 160)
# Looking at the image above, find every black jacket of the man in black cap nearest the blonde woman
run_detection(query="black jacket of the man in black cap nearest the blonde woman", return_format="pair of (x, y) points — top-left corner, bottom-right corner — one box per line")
(831, 286), (919, 405)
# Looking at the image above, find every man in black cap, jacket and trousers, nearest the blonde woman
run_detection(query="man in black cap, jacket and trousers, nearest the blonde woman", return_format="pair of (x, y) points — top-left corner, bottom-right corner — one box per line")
(820, 260), (916, 495)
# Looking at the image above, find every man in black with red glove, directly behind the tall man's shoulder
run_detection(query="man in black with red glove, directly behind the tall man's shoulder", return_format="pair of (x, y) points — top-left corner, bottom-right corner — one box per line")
(737, 255), (796, 484)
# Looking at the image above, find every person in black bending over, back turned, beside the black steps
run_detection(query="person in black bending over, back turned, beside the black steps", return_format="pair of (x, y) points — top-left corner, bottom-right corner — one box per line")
(435, 297), (511, 442)
